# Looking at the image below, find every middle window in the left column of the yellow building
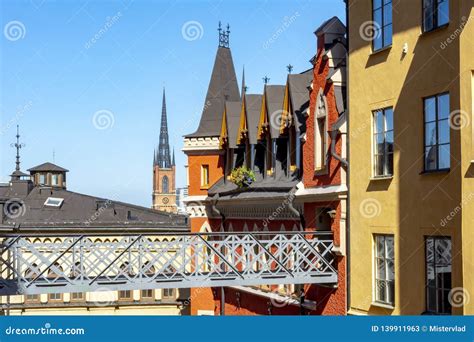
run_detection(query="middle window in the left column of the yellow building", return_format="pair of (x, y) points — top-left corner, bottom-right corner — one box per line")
(373, 108), (394, 177)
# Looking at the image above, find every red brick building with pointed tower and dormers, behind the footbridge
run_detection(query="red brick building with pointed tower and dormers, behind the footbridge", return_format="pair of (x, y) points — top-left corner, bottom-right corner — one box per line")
(184, 17), (347, 315)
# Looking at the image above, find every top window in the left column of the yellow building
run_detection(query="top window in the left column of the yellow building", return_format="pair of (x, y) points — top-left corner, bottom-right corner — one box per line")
(372, 0), (392, 51)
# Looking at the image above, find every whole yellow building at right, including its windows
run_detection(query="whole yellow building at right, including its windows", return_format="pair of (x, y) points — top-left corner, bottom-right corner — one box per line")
(347, 0), (474, 315)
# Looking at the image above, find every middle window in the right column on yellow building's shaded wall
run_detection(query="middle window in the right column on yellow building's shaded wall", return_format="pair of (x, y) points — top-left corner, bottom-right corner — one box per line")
(424, 93), (450, 171)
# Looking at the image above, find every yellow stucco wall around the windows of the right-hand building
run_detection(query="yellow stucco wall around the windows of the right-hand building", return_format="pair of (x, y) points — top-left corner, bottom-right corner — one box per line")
(348, 0), (474, 315)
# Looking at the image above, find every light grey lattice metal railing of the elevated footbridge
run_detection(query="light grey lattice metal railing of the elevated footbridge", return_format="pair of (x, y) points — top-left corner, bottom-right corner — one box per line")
(0, 232), (337, 294)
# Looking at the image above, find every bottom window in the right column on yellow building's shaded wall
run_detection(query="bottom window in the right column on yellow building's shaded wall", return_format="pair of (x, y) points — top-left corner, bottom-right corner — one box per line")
(425, 237), (451, 314)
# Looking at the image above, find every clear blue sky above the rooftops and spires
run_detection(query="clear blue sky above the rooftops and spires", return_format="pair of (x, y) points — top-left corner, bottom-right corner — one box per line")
(0, 0), (344, 206)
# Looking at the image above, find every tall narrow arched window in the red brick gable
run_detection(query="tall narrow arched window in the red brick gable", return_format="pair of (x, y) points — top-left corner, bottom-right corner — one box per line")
(314, 89), (328, 171)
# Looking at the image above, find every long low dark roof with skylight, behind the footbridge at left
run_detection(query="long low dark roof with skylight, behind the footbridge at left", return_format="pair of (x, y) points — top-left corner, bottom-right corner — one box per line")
(0, 187), (188, 232)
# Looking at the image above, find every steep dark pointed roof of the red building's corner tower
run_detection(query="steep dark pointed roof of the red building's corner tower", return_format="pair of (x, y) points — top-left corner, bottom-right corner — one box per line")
(186, 47), (240, 138)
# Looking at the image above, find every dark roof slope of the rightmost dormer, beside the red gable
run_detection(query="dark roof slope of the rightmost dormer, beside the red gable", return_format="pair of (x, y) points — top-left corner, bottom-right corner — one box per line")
(288, 69), (313, 132)
